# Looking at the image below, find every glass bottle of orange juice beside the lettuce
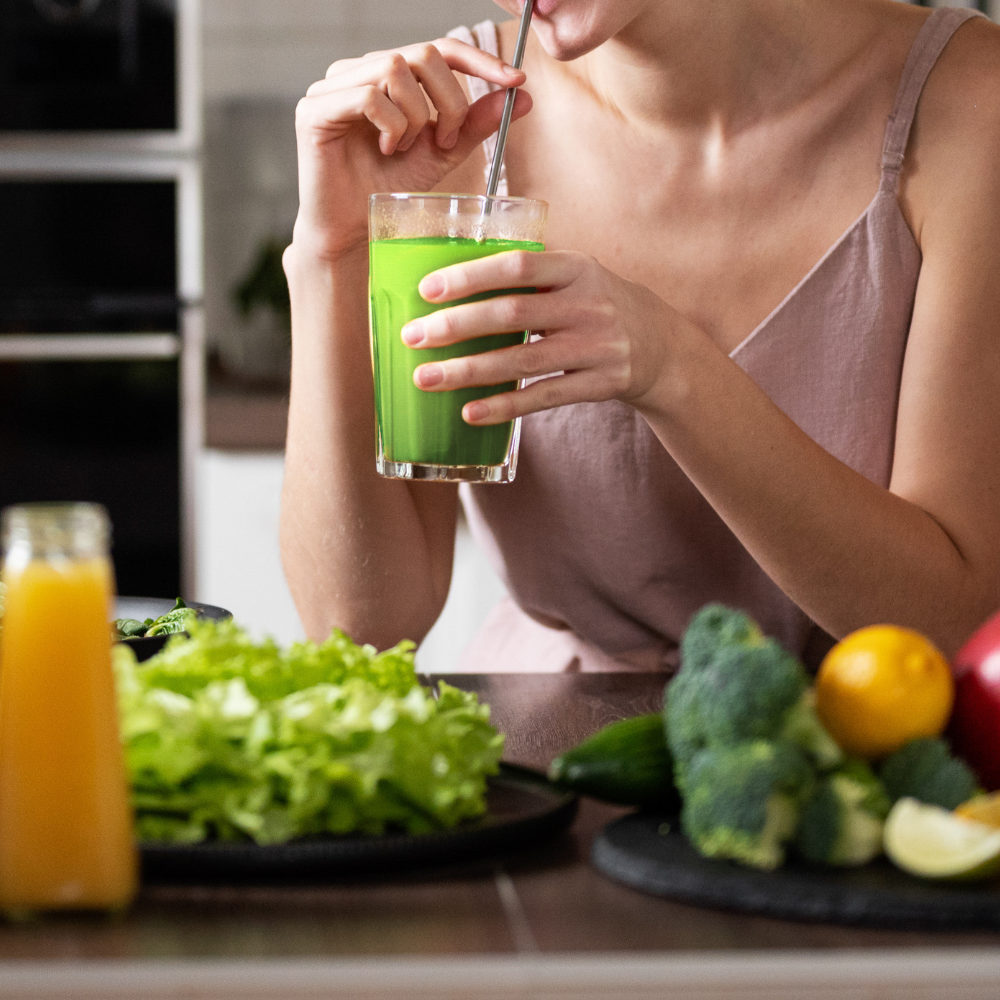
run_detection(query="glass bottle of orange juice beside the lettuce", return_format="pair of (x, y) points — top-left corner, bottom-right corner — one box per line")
(0, 504), (137, 912)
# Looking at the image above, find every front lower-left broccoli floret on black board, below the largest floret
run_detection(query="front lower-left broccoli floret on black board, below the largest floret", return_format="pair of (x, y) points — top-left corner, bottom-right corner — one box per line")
(681, 740), (814, 869)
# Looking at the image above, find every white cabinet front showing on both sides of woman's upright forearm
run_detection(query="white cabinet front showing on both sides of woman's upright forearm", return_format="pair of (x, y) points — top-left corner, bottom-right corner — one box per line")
(196, 450), (505, 673)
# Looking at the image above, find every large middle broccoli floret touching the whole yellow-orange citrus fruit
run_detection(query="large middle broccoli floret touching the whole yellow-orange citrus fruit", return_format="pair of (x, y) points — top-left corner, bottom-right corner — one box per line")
(664, 639), (844, 791)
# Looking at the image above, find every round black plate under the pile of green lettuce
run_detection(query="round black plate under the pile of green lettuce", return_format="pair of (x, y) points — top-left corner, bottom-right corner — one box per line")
(140, 764), (577, 883)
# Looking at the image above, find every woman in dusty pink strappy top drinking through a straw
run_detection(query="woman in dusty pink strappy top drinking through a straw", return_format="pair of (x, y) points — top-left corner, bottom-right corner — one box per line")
(282, 0), (1000, 670)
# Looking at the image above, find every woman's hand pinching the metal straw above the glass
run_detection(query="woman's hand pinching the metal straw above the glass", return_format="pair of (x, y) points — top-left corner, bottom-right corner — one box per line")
(294, 38), (531, 260)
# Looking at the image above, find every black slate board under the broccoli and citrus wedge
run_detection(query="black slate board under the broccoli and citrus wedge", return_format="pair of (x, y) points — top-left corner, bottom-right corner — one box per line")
(591, 813), (1000, 931)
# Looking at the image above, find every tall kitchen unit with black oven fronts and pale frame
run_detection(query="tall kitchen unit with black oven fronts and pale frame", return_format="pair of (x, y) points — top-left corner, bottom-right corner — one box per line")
(0, 0), (204, 596)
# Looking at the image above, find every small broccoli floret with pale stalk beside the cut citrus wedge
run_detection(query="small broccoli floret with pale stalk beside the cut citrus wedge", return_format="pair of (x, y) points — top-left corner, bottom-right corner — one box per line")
(796, 760), (890, 865)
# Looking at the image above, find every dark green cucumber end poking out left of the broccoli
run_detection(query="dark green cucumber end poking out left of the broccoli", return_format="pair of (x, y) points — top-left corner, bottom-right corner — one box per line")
(549, 713), (679, 808)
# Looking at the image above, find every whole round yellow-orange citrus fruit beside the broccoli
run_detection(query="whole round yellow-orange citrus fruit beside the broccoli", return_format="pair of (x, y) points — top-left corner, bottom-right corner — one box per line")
(816, 625), (955, 760)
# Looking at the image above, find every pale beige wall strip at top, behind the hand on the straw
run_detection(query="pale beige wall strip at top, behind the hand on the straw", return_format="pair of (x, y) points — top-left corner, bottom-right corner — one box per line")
(203, 0), (507, 101)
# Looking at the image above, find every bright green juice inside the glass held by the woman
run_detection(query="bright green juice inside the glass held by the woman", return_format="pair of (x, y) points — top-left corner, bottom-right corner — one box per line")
(369, 236), (544, 466)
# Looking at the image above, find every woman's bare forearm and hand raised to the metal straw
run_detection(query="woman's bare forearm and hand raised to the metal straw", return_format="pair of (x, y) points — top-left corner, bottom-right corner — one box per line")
(281, 39), (530, 648)
